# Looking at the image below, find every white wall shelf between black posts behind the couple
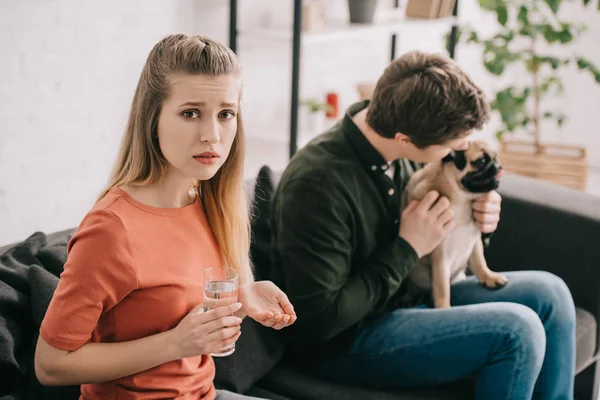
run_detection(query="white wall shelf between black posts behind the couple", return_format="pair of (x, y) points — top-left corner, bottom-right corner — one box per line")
(239, 9), (458, 45)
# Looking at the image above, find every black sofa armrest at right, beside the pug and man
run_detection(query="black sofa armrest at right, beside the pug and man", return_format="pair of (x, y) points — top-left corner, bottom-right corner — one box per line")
(486, 175), (600, 346)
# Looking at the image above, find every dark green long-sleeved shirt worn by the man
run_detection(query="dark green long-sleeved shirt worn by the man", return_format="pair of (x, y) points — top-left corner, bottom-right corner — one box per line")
(271, 101), (417, 361)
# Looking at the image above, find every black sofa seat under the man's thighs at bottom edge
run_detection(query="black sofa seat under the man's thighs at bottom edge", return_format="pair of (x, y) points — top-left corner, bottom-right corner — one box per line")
(257, 364), (474, 400)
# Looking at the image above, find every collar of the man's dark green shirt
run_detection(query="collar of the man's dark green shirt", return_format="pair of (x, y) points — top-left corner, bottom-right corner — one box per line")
(343, 100), (390, 174)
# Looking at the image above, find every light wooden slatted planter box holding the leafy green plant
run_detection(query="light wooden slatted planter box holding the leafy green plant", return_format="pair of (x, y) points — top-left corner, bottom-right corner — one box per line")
(498, 140), (588, 190)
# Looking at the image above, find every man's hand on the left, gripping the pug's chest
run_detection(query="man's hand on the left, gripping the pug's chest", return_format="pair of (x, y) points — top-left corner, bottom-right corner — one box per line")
(399, 191), (455, 258)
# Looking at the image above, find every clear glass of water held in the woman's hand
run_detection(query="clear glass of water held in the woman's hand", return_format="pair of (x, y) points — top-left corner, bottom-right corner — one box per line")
(204, 267), (239, 357)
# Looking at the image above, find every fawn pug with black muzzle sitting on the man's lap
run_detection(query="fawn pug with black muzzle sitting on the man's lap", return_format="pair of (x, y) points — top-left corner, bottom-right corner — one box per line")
(402, 141), (508, 308)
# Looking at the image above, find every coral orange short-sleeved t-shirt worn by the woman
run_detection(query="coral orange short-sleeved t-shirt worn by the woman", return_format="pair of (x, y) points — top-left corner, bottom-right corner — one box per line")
(40, 188), (223, 400)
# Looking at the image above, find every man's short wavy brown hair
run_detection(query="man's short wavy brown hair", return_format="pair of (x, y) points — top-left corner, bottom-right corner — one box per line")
(367, 51), (490, 148)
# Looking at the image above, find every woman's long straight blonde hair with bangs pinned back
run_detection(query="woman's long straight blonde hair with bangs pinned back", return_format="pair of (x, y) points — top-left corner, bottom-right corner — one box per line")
(100, 34), (253, 283)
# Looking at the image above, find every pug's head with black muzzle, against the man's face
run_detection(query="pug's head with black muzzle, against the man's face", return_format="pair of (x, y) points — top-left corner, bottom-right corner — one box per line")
(443, 140), (502, 193)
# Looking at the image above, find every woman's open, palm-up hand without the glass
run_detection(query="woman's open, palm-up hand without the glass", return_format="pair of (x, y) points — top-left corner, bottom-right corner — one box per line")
(238, 281), (296, 330)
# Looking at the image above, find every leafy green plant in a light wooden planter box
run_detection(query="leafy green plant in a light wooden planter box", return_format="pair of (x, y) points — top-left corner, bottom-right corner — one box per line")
(460, 0), (600, 189)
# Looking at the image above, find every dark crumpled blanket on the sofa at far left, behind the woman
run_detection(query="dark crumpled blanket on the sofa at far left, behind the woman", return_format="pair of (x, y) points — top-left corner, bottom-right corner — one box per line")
(0, 232), (79, 400)
